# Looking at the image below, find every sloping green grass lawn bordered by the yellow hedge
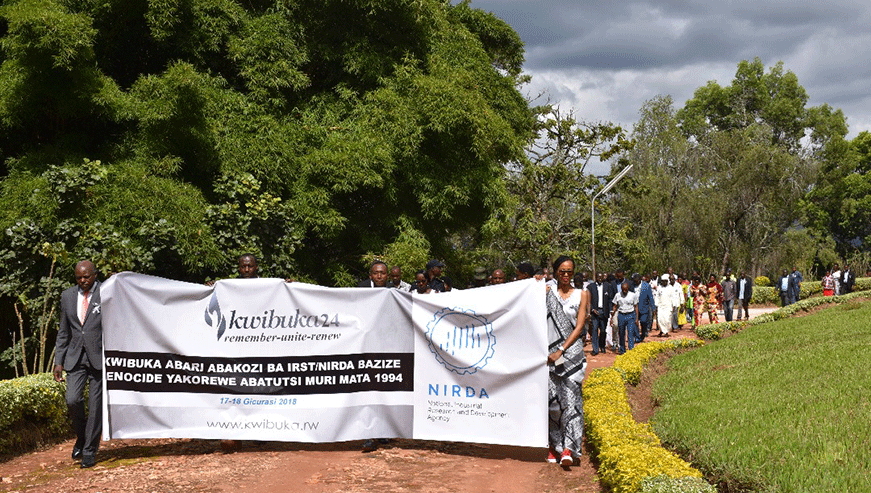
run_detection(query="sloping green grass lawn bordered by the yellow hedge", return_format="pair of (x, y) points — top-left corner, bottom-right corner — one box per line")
(651, 302), (871, 492)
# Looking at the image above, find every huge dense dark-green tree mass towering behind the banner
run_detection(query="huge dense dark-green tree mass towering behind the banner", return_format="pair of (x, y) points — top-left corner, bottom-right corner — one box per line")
(0, 0), (534, 374)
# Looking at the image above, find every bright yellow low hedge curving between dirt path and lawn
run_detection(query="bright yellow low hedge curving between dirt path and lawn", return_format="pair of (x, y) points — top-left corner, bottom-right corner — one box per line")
(583, 339), (716, 493)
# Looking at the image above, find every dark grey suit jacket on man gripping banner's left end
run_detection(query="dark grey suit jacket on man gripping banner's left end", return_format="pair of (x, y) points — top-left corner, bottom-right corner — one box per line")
(54, 281), (103, 371)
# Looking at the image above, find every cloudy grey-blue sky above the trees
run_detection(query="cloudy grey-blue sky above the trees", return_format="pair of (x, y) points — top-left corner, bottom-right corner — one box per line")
(471, 0), (871, 172)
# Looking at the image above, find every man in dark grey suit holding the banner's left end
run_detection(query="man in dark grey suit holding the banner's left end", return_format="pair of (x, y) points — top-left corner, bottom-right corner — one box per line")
(54, 260), (103, 468)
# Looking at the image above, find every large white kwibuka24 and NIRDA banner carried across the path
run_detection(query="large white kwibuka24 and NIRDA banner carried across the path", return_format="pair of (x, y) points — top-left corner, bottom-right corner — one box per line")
(100, 273), (547, 447)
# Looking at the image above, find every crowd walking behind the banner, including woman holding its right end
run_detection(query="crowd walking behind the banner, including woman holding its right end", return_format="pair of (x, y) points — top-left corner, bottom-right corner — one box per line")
(359, 256), (780, 467)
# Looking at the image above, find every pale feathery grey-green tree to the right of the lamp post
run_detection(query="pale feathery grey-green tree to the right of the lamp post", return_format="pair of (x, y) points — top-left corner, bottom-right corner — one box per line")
(621, 83), (822, 274)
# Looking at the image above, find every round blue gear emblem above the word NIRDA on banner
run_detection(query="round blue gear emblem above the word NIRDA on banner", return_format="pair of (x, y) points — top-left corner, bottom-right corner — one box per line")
(426, 307), (496, 375)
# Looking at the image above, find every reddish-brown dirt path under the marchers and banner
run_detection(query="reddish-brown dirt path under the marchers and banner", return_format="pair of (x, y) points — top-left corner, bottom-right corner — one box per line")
(0, 308), (773, 493)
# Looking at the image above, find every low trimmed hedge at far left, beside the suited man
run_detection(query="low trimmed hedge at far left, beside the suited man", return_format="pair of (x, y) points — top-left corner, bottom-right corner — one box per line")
(0, 373), (70, 455)
